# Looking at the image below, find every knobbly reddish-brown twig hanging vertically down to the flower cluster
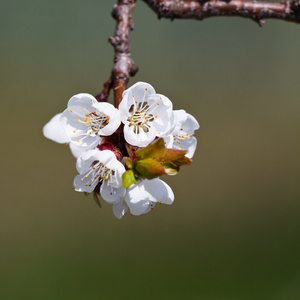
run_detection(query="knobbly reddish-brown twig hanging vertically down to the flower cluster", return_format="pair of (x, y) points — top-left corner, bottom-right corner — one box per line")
(108, 0), (138, 107)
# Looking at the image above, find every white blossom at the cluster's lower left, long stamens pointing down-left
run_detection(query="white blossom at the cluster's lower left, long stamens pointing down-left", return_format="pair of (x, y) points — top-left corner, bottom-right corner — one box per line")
(73, 149), (125, 203)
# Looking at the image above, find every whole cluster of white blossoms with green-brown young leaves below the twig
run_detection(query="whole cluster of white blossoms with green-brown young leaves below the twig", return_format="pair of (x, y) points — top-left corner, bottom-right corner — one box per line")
(43, 82), (199, 219)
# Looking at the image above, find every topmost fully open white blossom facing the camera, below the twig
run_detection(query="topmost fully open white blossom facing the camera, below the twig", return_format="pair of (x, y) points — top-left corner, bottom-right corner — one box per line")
(119, 82), (175, 147)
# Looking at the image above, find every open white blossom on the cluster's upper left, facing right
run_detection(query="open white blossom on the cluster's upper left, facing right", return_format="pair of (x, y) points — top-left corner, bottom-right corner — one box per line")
(60, 93), (121, 149)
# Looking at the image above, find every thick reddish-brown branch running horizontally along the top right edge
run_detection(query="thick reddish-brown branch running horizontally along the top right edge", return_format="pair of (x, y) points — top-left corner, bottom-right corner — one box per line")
(143, 0), (300, 26)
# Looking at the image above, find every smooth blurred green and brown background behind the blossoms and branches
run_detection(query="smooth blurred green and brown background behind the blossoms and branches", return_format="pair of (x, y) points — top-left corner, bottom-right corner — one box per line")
(0, 0), (300, 300)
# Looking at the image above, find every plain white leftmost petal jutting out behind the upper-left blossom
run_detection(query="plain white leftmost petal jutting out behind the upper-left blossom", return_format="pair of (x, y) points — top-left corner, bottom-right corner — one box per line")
(43, 113), (70, 144)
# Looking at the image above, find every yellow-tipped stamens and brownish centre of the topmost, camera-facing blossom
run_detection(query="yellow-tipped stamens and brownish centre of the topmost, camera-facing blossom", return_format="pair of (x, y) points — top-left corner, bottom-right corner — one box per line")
(128, 102), (154, 134)
